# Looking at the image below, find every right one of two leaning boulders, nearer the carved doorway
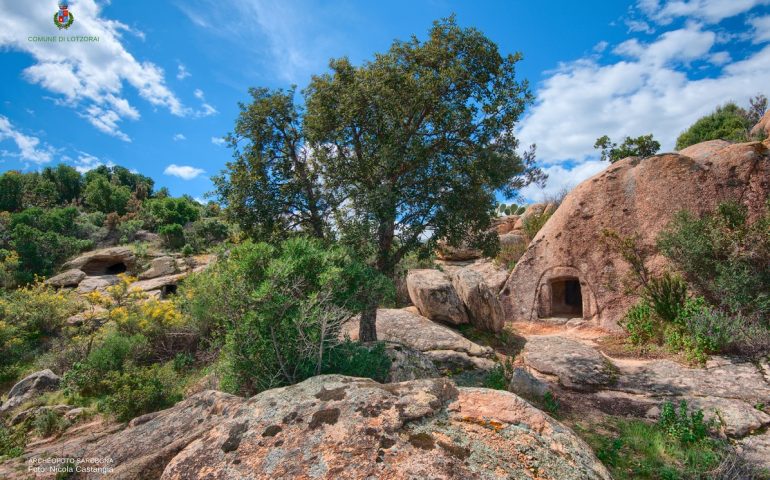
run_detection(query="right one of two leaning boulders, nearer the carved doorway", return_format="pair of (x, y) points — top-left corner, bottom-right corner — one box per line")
(452, 268), (505, 332)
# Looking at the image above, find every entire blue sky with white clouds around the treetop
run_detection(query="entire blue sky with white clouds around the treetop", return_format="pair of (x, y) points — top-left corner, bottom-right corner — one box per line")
(0, 0), (770, 200)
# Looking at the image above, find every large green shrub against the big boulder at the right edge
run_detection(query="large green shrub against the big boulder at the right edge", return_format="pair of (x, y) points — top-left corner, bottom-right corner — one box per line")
(658, 203), (770, 319)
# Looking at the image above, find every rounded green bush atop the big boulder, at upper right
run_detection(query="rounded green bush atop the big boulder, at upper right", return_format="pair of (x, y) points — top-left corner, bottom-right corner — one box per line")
(676, 103), (756, 150)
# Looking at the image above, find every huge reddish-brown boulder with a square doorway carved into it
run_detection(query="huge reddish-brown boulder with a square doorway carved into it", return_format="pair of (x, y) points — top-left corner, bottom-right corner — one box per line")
(501, 142), (770, 329)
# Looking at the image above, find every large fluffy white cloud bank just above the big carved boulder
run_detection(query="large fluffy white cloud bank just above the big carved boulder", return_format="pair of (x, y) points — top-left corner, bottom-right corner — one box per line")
(517, 26), (770, 171)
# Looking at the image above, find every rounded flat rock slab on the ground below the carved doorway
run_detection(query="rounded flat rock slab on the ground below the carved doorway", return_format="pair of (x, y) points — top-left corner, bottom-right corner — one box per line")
(524, 336), (617, 392)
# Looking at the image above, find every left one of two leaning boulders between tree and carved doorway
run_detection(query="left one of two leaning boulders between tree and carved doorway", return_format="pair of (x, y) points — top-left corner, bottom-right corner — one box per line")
(406, 269), (468, 325)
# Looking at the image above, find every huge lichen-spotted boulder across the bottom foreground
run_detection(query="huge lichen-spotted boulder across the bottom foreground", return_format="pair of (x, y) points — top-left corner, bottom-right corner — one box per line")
(0, 375), (610, 480)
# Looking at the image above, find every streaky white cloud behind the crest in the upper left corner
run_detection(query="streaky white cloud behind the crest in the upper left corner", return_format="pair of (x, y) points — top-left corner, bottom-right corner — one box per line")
(0, 0), (188, 141)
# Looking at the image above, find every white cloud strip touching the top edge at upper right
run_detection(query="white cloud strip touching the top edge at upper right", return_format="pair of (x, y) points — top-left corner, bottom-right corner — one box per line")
(638, 0), (770, 25)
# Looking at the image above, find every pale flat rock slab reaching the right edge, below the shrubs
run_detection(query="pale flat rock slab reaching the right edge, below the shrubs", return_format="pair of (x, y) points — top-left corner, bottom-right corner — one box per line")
(613, 357), (770, 405)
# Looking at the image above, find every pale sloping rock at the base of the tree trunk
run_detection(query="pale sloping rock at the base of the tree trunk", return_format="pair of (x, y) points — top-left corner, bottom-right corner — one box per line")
(342, 308), (494, 370)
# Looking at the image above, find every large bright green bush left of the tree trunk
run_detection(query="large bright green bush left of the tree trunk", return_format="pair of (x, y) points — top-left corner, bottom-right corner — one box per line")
(179, 238), (392, 393)
